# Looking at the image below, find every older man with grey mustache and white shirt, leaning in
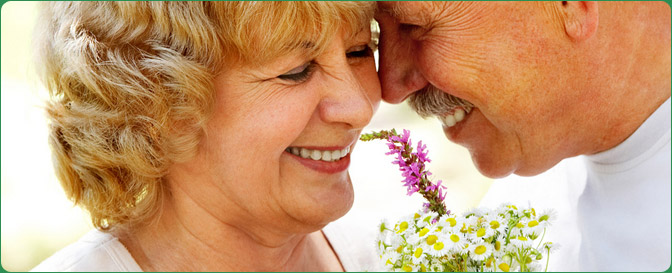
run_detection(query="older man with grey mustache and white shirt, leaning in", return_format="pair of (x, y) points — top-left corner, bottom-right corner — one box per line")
(376, 1), (671, 271)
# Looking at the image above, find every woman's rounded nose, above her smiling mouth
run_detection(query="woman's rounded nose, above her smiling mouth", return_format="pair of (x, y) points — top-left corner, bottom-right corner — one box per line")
(319, 66), (380, 129)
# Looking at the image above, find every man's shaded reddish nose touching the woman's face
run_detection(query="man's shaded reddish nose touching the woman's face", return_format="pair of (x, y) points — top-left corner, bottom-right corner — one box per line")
(376, 12), (427, 103)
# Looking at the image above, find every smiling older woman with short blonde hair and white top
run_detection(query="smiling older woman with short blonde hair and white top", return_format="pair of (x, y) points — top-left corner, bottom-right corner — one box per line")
(34, 2), (380, 271)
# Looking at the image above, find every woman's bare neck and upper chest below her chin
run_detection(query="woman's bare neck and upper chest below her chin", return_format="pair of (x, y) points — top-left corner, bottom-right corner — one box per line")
(116, 184), (343, 271)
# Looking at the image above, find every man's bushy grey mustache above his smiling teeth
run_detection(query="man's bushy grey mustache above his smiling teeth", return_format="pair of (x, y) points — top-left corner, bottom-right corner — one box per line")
(408, 85), (474, 118)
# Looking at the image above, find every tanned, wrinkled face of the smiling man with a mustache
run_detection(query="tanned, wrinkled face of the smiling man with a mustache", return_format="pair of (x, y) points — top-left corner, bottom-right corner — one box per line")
(376, 2), (581, 177)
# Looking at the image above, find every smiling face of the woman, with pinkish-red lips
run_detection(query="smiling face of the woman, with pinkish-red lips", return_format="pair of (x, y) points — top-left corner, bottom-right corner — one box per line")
(171, 25), (380, 229)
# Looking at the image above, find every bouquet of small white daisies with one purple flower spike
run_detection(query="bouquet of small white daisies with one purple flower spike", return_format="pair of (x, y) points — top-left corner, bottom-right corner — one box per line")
(360, 129), (558, 272)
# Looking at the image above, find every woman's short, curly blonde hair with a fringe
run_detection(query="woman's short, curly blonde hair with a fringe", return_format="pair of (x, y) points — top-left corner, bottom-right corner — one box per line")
(36, 2), (375, 230)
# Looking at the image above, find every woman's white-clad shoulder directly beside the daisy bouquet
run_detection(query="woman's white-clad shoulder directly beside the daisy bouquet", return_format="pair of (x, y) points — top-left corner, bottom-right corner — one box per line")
(322, 213), (381, 272)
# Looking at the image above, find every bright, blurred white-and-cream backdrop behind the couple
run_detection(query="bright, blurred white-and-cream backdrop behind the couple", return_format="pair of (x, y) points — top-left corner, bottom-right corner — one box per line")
(0, 2), (492, 271)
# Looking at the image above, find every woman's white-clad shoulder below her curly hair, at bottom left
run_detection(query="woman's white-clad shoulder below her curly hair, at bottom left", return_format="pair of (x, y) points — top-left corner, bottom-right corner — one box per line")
(31, 230), (142, 272)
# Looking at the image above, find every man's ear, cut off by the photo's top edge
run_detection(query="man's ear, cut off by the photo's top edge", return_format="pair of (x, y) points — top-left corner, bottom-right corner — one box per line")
(560, 1), (599, 42)
